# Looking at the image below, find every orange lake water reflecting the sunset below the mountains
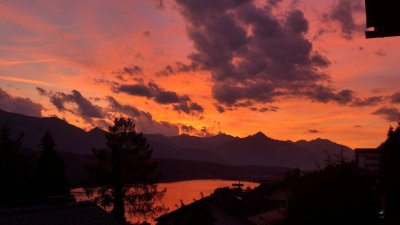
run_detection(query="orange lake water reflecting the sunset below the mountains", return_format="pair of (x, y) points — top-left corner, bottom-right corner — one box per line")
(72, 180), (258, 222)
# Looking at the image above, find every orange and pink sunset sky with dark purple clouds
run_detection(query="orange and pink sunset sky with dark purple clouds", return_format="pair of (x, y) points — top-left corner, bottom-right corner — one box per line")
(0, 0), (400, 148)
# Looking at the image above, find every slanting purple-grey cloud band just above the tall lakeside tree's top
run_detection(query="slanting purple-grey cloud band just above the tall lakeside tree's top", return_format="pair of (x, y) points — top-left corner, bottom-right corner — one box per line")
(106, 96), (179, 136)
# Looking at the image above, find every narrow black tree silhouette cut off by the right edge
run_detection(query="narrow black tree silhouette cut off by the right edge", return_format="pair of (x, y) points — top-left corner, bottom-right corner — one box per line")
(378, 123), (400, 224)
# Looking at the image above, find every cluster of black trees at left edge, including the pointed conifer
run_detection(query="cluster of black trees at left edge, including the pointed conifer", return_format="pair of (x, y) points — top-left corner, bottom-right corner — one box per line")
(0, 126), (73, 208)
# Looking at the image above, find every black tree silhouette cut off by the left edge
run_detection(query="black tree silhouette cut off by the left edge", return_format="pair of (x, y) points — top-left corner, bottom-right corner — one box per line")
(0, 125), (33, 208)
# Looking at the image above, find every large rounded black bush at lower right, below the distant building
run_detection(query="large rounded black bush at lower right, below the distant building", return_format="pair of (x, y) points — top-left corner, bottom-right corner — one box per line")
(286, 161), (379, 225)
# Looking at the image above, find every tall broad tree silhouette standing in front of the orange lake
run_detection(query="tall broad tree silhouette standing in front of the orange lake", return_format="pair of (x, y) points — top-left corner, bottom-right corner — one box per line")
(87, 117), (165, 221)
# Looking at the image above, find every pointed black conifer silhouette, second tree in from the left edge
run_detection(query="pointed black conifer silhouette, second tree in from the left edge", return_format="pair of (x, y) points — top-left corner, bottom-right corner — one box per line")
(34, 131), (71, 199)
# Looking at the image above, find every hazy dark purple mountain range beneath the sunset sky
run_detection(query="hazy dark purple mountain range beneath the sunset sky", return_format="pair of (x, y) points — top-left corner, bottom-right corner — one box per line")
(0, 110), (353, 170)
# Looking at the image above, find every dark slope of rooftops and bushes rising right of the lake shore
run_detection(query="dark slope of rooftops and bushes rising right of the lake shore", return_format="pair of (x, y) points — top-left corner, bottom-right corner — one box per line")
(157, 159), (381, 225)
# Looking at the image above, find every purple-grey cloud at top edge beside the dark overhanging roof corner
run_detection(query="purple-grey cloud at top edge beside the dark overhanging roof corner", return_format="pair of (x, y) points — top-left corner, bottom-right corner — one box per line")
(325, 0), (364, 39)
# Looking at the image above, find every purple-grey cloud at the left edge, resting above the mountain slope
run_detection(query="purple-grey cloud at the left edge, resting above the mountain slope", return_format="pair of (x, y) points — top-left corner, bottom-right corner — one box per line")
(0, 88), (43, 117)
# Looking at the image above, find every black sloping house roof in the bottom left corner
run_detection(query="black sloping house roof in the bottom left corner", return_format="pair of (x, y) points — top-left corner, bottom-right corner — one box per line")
(0, 202), (124, 225)
